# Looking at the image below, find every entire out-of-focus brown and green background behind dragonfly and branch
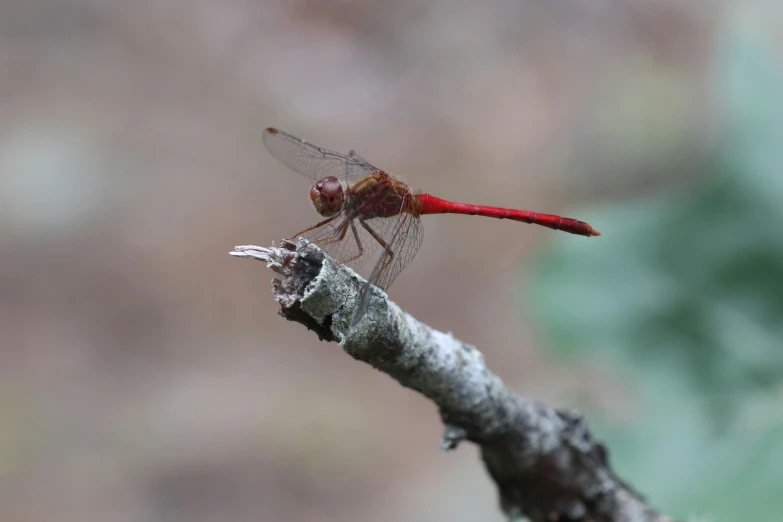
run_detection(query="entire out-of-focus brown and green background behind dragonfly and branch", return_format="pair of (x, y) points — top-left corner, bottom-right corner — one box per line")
(0, 0), (783, 522)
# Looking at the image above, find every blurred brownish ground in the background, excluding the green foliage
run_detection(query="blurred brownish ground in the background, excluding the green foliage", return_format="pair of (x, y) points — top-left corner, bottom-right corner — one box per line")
(0, 0), (728, 522)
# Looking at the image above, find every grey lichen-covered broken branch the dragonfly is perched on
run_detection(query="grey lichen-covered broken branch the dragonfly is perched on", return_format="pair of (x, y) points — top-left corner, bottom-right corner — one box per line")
(231, 240), (671, 522)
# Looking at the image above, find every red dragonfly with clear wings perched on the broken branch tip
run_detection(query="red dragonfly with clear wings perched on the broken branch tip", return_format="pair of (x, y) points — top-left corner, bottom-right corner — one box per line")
(263, 127), (601, 324)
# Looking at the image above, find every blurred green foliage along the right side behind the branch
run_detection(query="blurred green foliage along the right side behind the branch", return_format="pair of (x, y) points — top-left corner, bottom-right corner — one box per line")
(525, 11), (783, 522)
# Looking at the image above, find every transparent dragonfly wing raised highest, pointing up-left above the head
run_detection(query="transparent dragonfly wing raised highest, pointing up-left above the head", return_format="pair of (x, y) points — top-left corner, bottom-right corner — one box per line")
(264, 128), (378, 181)
